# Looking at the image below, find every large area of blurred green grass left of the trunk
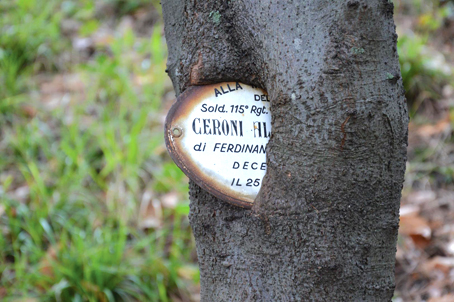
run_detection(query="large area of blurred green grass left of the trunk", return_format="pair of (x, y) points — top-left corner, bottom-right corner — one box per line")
(0, 0), (199, 301)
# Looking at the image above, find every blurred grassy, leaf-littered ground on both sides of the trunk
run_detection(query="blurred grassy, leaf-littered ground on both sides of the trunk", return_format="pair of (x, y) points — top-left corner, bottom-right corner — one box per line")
(0, 0), (454, 302)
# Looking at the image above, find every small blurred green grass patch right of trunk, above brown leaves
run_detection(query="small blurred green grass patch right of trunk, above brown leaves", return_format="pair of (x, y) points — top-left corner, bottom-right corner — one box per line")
(396, 0), (454, 117)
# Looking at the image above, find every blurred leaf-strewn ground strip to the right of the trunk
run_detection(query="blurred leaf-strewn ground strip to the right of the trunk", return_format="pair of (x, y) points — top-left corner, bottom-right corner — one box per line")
(395, 2), (454, 302)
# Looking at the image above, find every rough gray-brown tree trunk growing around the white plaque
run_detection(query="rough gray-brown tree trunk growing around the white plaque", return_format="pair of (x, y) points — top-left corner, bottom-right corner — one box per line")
(162, 0), (408, 302)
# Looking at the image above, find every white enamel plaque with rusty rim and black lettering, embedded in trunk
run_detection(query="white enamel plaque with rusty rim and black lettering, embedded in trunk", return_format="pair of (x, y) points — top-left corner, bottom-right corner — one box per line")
(165, 82), (271, 207)
